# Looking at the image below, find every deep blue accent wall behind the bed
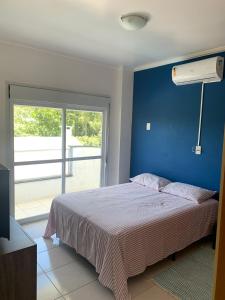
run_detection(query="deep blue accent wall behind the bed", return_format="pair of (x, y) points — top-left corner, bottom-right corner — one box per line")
(131, 53), (225, 190)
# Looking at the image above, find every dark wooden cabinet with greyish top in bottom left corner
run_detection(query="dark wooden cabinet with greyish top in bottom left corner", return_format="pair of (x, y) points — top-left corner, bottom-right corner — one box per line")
(0, 219), (37, 300)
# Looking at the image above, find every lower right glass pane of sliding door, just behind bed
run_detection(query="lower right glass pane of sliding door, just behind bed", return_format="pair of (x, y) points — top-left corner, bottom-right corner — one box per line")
(66, 159), (101, 193)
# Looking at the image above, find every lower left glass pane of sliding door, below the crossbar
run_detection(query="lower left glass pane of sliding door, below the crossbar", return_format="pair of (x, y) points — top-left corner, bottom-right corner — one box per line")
(15, 163), (62, 219)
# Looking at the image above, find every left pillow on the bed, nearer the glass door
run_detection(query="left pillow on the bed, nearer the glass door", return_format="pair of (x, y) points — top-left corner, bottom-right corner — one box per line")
(130, 173), (171, 191)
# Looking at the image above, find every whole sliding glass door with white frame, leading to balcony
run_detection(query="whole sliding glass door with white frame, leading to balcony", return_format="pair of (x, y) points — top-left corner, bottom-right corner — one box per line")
(13, 101), (107, 219)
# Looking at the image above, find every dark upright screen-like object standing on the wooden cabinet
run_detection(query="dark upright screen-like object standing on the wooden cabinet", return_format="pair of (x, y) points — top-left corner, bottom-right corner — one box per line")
(0, 164), (10, 239)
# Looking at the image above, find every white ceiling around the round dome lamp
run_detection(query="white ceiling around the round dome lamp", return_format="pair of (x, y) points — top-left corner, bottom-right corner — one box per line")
(0, 0), (225, 67)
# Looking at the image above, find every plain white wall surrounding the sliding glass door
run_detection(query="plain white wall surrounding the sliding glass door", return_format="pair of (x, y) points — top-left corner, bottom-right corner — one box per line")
(0, 40), (132, 184)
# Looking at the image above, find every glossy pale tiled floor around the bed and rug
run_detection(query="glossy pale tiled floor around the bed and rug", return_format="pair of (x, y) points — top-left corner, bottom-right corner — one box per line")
(23, 221), (181, 300)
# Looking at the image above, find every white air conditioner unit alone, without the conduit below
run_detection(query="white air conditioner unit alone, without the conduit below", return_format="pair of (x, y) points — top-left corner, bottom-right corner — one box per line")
(172, 56), (224, 85)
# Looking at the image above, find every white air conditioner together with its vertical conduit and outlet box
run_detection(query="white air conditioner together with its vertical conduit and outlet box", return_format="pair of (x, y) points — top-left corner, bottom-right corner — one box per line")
(172, 56), (224, 154)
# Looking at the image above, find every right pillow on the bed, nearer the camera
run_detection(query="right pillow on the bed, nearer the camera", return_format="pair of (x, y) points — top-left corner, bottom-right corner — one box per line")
(161, 182), (216, 204)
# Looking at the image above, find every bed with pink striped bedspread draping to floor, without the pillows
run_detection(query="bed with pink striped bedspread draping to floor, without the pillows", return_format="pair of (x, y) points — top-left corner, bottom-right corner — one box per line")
(45, 182), (218, 300)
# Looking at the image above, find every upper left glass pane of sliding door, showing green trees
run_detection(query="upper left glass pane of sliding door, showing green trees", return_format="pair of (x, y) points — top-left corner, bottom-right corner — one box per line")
(14, 105), (62, 162)
